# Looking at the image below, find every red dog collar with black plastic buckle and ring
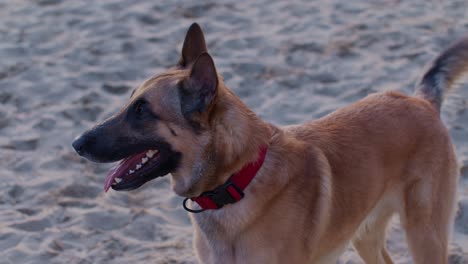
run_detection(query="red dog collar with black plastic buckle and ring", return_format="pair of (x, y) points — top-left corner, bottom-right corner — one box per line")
(183, 145), (268, 213)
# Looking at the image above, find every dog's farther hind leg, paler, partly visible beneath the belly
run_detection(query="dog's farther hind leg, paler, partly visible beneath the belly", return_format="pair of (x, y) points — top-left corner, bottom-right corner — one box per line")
(353, 206), (393, 264)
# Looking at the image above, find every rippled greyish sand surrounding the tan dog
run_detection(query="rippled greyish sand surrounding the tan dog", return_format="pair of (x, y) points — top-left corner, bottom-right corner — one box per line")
(0, 0), (468, 264)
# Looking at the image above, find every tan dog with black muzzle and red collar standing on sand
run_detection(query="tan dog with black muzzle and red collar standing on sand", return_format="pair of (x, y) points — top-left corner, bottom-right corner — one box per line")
(73, 23), (468, 264)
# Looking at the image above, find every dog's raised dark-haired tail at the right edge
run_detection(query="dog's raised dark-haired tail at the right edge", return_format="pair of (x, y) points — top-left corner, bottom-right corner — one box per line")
(415, 37), (468, 112)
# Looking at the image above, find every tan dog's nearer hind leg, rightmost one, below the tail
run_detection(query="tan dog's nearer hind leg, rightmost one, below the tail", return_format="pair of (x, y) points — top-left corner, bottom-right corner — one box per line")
(402, 162), (457, 264)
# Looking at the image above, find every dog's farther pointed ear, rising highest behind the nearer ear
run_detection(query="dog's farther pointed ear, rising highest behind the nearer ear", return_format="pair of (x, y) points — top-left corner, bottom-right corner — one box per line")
(179, 23), (207, 67)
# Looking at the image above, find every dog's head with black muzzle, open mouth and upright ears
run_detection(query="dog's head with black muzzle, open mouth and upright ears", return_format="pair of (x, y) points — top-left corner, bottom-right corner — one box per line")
(73, 24), (238, 195)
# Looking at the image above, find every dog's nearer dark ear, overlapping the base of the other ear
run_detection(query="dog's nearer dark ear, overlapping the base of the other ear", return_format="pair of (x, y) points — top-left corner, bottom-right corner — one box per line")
(180, 52), (218, 117)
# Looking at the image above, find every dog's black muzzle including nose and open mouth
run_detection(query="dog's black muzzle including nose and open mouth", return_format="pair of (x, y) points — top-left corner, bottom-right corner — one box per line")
(72, 108), (182, 191)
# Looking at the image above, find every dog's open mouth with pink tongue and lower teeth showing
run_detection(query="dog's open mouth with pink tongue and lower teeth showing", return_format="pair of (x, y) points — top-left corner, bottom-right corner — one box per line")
(104, 146), (178, 192)
